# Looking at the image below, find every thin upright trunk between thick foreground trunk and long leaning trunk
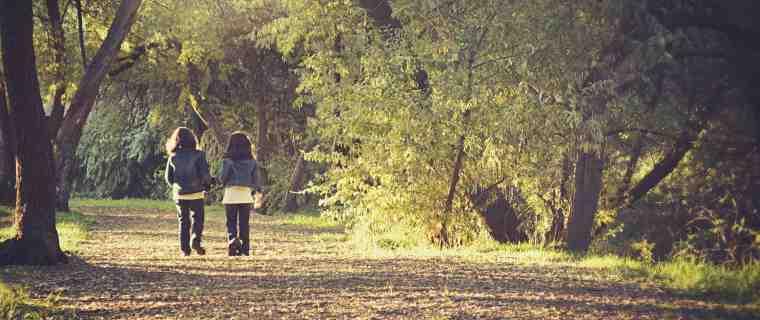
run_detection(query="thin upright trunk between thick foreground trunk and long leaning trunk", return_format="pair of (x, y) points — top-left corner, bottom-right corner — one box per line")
(47, 0), (66, 139)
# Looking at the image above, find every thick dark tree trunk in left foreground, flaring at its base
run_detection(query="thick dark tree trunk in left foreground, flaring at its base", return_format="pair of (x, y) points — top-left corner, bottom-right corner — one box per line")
(0, 1), (66, 265)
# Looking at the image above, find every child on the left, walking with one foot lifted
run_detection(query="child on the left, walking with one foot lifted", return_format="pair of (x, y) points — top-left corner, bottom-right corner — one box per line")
(165, 127), (212, 256)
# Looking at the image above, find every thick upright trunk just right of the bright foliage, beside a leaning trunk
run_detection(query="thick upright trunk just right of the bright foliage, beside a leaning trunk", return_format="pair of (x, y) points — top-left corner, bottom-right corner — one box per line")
(567, 151), (604, 253)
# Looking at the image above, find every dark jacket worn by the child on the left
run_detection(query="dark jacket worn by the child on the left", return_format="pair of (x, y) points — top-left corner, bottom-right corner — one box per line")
(165, 150), (212, 194)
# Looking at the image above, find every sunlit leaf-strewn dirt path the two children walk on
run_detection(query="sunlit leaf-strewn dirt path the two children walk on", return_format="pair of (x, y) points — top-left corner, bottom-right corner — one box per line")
(0, 208), (752, 319)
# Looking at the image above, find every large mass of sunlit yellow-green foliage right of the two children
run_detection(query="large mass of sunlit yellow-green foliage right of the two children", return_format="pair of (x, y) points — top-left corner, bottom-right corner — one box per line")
(263, 1), (628, 248)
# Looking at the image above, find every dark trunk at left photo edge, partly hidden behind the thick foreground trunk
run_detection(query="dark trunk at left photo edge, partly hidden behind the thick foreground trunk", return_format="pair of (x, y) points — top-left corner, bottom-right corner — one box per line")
(0, 70), (16, 205)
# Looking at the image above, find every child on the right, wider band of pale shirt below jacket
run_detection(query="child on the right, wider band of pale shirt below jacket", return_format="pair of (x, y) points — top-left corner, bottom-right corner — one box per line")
(218, 132), (258, 256)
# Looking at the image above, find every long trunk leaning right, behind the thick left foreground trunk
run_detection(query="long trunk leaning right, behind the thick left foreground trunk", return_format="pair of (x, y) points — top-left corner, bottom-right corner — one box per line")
(56, 0), (142, 211)
